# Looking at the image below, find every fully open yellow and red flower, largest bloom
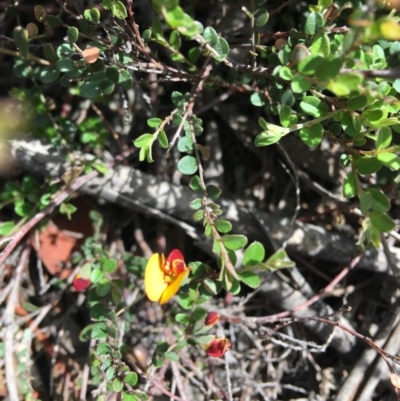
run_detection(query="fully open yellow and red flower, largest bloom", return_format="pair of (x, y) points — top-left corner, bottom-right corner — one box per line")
(144, 249), (191, 305)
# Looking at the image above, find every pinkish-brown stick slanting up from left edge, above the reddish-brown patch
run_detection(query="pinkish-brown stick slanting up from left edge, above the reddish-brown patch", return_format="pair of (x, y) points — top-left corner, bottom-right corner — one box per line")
(0, 171), (99, 266)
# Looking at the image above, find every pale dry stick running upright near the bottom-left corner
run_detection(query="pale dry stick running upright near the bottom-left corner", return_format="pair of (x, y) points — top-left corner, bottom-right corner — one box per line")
(3, 246), (30, 400)
